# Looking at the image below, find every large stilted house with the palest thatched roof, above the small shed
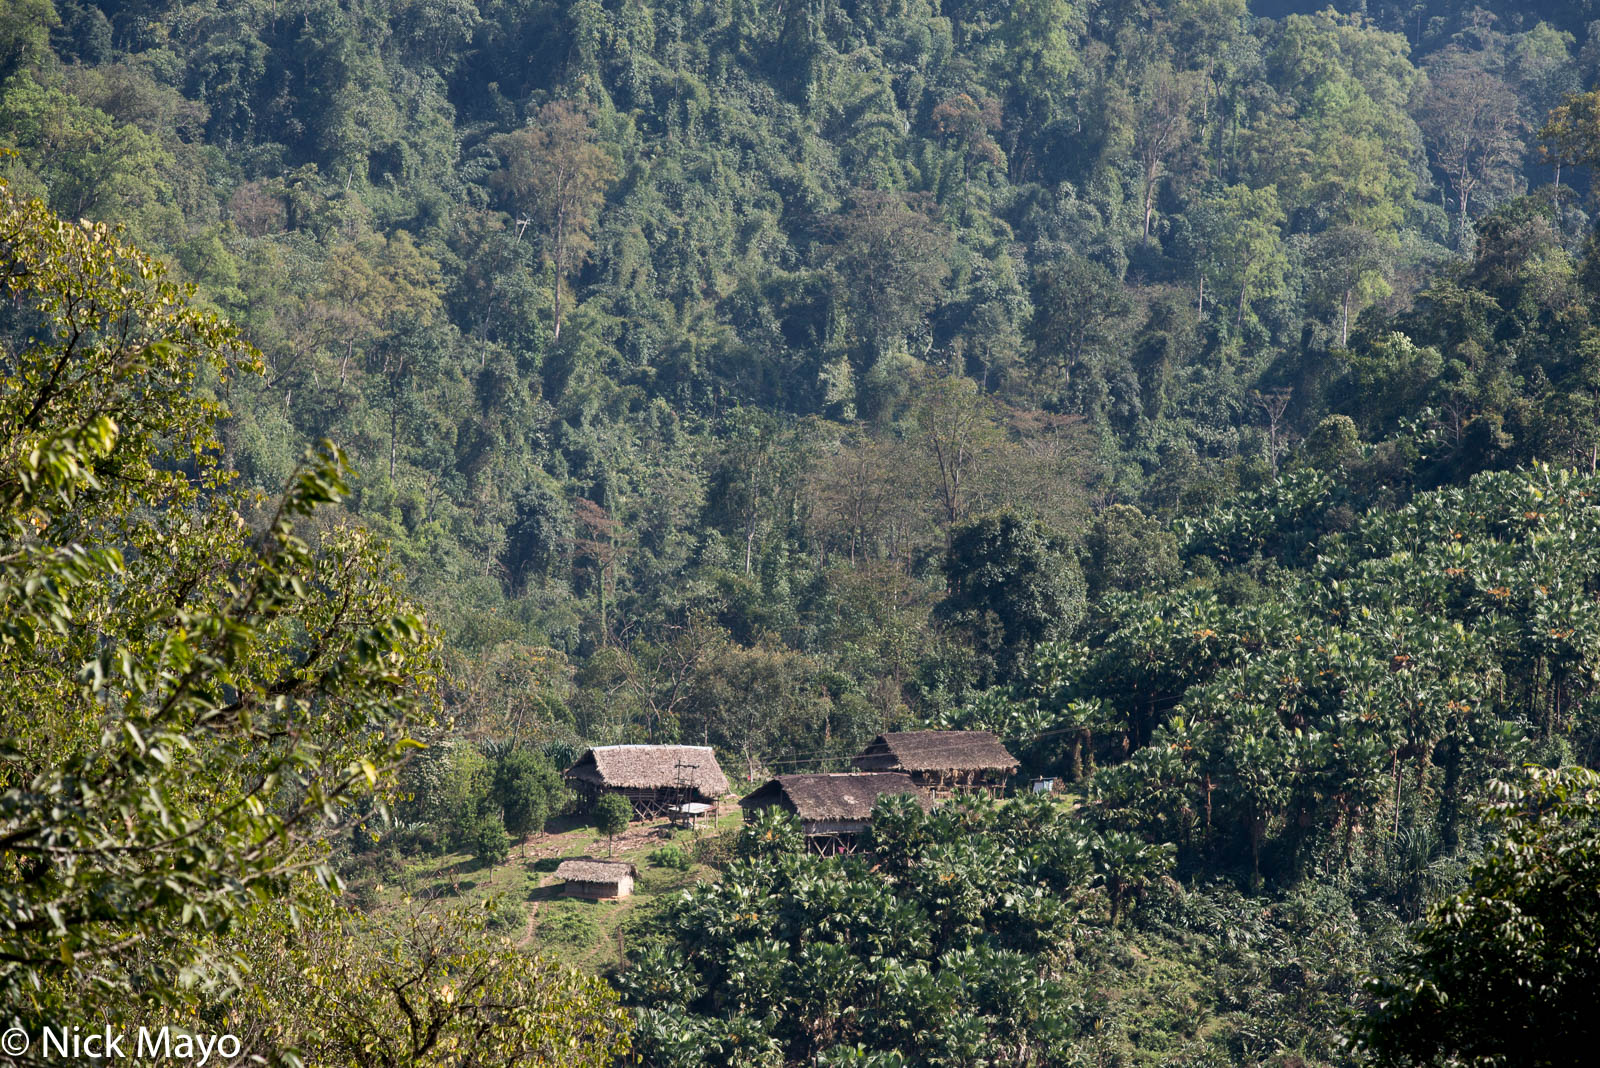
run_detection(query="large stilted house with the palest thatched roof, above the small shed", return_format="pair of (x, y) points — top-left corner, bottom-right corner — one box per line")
(566, 745), (728, 820)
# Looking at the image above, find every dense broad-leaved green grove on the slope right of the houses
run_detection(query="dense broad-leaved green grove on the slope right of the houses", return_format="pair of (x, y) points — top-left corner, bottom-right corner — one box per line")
(1011, 468), (1600, 910)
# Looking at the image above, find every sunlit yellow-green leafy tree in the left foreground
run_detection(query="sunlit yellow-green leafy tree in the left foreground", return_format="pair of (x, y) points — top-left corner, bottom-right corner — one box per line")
(0, 184), (432, 1023)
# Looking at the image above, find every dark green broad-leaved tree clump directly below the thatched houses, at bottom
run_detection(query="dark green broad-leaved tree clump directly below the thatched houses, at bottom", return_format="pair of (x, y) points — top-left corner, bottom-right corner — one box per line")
(618, 796), (1162, 1063)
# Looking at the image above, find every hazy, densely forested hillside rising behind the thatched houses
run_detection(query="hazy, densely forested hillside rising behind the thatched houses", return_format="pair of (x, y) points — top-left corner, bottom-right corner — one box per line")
(9, 0), (1600, 759)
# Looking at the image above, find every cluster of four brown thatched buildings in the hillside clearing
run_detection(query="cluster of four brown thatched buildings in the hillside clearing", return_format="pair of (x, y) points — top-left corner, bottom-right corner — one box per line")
(555, 731), (1018, 897)
